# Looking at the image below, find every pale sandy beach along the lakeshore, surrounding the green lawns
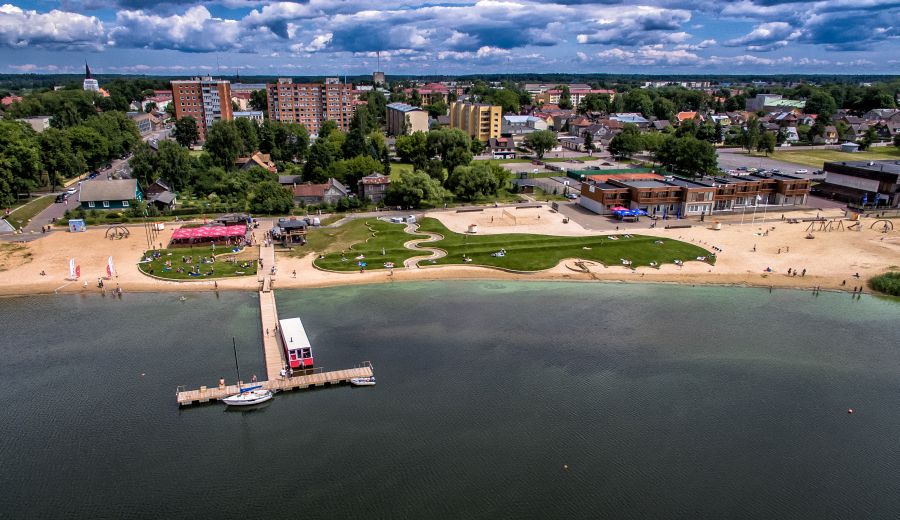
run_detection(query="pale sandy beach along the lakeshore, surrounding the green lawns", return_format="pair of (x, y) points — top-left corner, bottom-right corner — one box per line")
(0, 206), (900, 296)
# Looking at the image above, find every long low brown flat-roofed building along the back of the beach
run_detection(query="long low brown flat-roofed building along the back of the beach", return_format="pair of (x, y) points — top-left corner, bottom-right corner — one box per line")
(579, 173), (810, 216)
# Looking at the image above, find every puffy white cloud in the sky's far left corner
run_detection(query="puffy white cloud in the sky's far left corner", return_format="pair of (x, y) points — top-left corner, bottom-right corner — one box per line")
(0, 4), (104, 48)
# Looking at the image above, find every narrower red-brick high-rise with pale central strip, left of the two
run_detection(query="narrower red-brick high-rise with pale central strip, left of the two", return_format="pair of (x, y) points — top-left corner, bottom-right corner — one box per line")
(172, 76), (234, 141)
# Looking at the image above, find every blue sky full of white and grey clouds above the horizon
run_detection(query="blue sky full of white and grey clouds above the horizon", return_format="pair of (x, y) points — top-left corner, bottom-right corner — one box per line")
(0, 0), (900, 76)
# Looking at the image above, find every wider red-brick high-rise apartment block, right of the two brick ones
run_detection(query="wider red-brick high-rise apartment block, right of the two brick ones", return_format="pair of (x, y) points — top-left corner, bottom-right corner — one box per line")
(266, 78), (354, 134)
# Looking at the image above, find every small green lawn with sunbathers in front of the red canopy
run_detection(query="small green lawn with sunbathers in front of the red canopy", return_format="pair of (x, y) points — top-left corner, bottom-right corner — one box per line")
(139, 246), (257, 280)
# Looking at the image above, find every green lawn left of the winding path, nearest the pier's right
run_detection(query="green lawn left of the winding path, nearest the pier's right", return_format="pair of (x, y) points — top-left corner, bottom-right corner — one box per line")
(312, 219), (423, 271)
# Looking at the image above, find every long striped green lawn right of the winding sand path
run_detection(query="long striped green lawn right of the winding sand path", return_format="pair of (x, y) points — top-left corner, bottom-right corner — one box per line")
(420, 218), (715, 271)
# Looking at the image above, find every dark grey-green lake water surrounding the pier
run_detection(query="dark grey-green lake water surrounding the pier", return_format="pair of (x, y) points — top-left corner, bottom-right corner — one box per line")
(0, 282), (900, 520)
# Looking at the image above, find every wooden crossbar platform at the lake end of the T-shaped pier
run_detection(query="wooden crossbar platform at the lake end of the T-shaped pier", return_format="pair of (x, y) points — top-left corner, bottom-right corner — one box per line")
(176, 361), (373, 406)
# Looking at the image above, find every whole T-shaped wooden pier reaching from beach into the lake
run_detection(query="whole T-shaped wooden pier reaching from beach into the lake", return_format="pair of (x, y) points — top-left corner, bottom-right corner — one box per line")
(175, 232), (374, 406)
